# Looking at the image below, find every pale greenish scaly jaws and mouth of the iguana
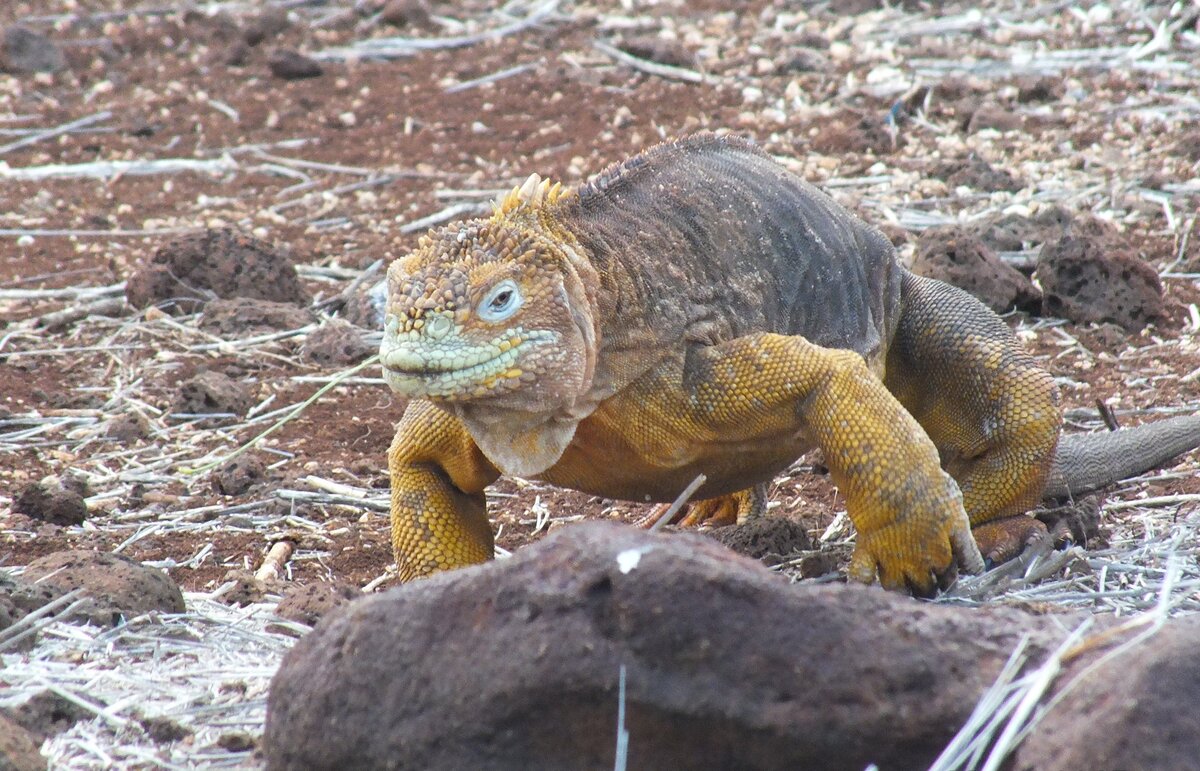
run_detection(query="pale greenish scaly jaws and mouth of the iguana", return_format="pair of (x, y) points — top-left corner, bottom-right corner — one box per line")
(379, 316), (558, 401)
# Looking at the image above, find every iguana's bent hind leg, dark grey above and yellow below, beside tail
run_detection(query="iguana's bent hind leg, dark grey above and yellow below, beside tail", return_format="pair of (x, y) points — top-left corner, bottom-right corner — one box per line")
(884, 274), (1061, 561)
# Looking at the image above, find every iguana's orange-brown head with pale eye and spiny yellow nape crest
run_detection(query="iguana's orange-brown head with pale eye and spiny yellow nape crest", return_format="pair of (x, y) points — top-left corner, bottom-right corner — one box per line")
(380, 175), (596, 412)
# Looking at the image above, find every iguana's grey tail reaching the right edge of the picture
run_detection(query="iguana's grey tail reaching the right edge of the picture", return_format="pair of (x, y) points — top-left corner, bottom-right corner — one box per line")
(1042, 414), (1200, 498)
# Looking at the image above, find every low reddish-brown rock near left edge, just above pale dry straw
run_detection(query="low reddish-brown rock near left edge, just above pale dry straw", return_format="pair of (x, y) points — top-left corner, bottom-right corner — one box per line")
(12, 550), (185, 626)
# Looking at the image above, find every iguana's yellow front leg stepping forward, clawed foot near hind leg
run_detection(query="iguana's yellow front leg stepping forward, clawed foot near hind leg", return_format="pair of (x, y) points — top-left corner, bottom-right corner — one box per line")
(684, 333), (983, 594)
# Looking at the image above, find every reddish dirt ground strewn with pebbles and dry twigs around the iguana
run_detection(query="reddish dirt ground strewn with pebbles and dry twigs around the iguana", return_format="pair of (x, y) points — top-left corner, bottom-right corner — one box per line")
(0, 0), (1200, 591)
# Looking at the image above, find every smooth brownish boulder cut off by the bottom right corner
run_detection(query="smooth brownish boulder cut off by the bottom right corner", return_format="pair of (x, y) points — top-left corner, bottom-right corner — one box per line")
(1008, 616), (1200, 771)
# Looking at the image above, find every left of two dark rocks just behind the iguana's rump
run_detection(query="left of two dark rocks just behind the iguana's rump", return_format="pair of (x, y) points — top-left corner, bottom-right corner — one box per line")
(911, 227), (1040, 313)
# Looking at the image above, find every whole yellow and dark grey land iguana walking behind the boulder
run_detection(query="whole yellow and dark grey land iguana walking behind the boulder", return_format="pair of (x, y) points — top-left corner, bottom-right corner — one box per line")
(380, 135), (1200, 594)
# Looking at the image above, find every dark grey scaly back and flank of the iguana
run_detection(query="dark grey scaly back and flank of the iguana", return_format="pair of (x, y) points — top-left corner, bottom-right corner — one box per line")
(564, 135), (901, 354)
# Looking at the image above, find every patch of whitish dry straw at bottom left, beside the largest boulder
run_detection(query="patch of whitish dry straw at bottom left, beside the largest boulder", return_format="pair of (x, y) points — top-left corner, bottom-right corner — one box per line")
(0, 593), (297, 767)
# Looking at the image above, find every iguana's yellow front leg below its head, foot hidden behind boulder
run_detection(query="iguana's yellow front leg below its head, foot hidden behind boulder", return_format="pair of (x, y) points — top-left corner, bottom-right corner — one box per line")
(388, 401), (500, 581)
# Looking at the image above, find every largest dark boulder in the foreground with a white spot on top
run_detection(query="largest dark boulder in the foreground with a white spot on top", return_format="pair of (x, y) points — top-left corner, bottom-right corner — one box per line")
(263, 522), (1072, 771)
